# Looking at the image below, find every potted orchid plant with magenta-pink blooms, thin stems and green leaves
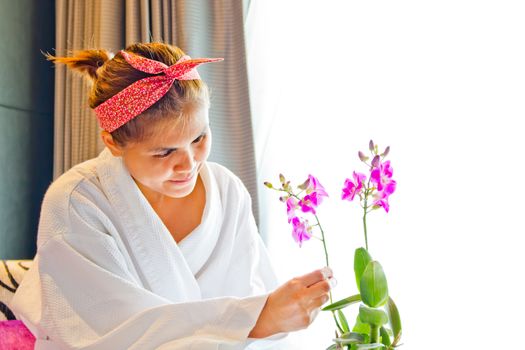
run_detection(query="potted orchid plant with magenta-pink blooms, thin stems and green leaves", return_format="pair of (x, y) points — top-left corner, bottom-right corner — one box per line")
(264, 140), (401, 350)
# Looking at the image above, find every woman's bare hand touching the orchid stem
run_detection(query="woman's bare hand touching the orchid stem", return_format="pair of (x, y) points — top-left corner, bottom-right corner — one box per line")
(249, 267), (335, 338)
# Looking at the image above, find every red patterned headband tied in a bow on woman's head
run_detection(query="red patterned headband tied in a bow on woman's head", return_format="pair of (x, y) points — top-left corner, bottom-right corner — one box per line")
(94, 50), (223, 132)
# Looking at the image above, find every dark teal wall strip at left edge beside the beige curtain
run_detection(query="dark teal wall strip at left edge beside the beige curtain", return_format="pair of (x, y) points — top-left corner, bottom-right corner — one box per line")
(0, 0), (55, 259)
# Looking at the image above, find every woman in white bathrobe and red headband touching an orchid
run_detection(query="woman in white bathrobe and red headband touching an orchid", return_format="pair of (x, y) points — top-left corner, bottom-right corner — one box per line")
(11, 43), (333, 349)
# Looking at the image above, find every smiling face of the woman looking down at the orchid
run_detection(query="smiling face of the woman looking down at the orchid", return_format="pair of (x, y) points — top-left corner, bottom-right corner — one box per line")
(109, 105), (211, 199)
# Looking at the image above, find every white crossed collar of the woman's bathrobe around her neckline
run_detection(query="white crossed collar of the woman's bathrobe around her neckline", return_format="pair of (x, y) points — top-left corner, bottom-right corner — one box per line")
(97, 148), (222, 302)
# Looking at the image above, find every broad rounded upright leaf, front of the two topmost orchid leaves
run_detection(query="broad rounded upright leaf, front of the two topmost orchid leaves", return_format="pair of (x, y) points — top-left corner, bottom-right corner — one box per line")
(361, 261), (388, 307)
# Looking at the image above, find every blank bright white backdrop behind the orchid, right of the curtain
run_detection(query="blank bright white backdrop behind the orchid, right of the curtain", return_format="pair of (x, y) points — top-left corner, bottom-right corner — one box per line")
(247, 0), (525, 350)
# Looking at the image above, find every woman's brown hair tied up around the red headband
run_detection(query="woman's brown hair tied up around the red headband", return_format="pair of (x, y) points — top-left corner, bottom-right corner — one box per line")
(46, 42), (209, 146)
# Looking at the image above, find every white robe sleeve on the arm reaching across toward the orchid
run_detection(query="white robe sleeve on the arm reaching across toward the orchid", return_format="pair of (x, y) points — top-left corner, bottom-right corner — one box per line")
(12, 185), (268, 350)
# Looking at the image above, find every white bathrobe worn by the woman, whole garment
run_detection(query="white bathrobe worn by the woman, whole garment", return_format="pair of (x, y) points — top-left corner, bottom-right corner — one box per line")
(10, 149), (284, 350)
